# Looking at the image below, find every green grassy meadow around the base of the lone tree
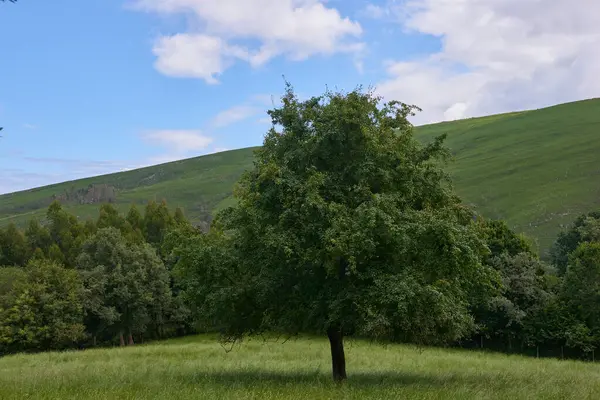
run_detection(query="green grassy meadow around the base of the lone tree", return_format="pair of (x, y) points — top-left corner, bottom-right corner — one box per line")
(0, 336), (600, 400)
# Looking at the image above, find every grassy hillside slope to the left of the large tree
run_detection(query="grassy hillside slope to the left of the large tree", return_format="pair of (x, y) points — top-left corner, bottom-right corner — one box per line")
(0, 149), (253, 225)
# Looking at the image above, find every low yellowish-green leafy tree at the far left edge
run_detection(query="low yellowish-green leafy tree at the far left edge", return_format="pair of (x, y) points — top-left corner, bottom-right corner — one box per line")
(0, 260), (84, 353)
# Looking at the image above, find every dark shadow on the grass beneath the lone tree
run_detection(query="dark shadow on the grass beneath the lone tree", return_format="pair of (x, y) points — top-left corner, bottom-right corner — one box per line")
(188, 371), (474, 389)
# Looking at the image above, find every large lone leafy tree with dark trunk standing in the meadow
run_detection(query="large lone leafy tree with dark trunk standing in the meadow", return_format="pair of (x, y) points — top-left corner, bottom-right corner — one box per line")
(181, 85), (494, 381)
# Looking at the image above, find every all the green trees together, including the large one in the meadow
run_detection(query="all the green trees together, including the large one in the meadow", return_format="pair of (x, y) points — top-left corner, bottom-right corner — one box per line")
(0, 85), (600, 381)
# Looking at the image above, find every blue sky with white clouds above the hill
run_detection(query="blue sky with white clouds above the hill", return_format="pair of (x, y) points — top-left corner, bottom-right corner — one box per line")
(0, 0), (600, 193)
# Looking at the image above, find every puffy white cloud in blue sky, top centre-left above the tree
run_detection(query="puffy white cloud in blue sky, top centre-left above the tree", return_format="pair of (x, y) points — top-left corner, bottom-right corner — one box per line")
(134, 0), (363, 84)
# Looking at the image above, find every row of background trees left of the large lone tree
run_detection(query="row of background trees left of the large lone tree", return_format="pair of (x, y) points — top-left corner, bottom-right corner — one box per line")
(0, 201), (195, 354)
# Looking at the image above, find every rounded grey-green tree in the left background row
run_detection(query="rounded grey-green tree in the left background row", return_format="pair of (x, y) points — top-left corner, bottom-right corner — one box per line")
(77, 227), (171, 344)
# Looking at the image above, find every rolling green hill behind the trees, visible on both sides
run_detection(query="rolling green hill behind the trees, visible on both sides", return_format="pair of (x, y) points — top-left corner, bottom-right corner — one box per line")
(0, 99), (600, 254)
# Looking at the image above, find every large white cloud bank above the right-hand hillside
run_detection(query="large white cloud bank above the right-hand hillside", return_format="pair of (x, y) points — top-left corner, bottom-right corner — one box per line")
(377, 0), (600, 123)
